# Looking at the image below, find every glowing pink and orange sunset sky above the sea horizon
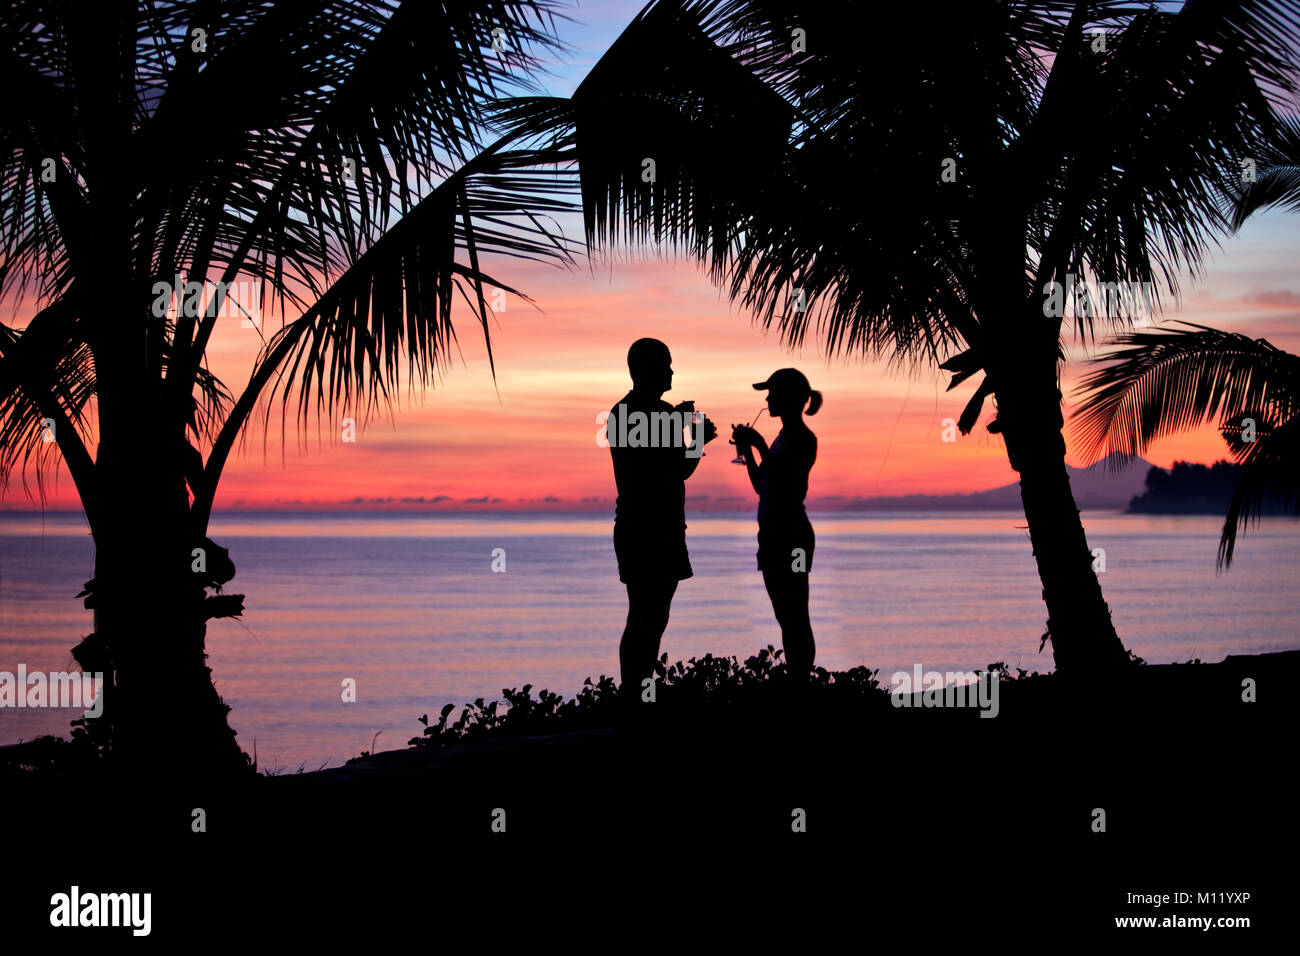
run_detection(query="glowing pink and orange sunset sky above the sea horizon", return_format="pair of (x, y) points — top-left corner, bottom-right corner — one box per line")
(0, 213), (1300, 510)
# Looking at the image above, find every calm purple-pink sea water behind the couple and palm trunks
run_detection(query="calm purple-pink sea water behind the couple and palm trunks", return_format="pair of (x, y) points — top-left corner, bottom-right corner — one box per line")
(0, 512), (1300, 771)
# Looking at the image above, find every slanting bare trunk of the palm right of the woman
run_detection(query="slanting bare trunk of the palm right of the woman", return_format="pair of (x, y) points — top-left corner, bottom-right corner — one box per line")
(996, 356), (1131, 674)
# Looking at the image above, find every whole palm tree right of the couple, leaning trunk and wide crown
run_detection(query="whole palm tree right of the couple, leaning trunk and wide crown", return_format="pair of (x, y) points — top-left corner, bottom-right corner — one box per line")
(488, 0), (1300, 672)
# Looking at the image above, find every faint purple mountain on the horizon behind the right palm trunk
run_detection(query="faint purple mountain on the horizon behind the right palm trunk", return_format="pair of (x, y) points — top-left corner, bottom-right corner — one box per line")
(844, 451), (1159, 511)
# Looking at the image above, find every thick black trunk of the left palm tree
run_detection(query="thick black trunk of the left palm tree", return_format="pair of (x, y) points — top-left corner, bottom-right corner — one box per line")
(92, 329), (247, 779)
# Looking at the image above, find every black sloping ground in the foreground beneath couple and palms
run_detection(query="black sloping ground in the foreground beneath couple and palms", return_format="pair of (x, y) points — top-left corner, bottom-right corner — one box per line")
(3, 652), (1300, 951)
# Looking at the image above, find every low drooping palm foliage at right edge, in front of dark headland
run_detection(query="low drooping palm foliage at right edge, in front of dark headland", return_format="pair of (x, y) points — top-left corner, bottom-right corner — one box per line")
(1075, 323), (1300, 567)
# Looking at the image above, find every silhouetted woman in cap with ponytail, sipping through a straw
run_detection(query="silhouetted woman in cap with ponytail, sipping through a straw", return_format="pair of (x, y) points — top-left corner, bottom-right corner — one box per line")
(732, 368), (822, 679)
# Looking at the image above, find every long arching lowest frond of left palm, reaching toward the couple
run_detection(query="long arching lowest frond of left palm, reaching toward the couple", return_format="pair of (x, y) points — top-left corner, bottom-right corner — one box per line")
(194, 140), (579, 525)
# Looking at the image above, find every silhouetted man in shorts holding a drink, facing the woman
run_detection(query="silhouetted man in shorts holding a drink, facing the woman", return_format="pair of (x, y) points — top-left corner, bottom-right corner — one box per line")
(606, 338), (718, 705)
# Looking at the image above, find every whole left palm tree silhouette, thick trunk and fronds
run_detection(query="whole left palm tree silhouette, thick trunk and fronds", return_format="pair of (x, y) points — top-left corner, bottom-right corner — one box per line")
(0, 0), (576, 773)
